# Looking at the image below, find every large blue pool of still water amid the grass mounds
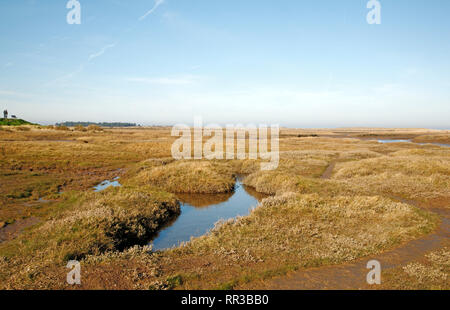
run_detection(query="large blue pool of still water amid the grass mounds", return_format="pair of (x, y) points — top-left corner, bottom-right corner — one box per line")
(151, 182), (267, 250)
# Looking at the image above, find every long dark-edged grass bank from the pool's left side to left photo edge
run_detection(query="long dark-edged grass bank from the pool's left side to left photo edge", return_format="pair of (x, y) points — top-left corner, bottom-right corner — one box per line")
(0, 187), (180, 287)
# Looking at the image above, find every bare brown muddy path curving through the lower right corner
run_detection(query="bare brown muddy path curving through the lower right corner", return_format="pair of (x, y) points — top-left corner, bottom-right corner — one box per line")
(246, 162), (450, 290)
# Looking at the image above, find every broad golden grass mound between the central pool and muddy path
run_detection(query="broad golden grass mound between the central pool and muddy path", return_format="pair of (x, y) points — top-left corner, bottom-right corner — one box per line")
(59, 193), (437, 289)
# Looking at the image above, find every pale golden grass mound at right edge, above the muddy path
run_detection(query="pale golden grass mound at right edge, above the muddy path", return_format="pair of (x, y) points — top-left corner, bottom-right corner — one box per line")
(333, 150), (450, 208)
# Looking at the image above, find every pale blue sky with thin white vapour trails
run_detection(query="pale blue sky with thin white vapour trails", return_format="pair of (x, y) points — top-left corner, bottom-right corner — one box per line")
(0, 0), (450, 129)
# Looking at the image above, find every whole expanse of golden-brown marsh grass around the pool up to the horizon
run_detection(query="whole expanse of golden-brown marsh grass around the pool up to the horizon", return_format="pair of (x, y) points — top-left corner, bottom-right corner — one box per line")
(0, 126), (450, 289)
